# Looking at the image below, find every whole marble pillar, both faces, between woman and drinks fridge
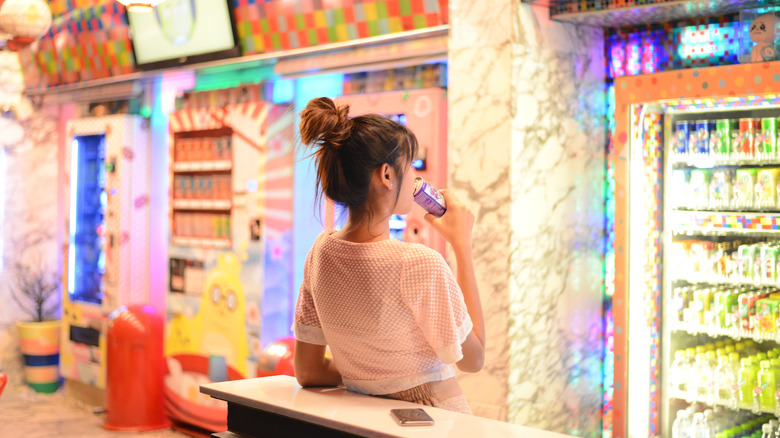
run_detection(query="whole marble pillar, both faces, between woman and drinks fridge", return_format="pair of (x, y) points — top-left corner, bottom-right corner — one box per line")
(448, 0), (606, 436)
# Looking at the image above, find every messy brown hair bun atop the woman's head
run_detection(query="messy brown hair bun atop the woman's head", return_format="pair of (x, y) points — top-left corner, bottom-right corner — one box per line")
(300, 97), (352, 149)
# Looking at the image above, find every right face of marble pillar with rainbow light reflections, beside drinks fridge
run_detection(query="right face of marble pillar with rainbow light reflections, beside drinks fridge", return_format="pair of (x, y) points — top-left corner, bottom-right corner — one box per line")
(507, 5), (606, 437)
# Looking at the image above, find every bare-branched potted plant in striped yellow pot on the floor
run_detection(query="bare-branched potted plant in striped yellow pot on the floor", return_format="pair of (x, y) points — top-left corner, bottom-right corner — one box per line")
(9, 262), (61, 393)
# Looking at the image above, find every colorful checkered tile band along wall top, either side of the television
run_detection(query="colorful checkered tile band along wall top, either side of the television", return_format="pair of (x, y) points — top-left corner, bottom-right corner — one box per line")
(20, 0), (449, 90)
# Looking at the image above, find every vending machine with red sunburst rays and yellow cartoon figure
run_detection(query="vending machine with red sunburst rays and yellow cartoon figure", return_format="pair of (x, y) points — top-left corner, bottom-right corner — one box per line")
(165, 101), (295, 431)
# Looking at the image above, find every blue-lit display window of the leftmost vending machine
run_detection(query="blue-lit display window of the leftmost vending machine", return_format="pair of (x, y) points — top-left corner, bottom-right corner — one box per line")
(68, 135), (107, 304)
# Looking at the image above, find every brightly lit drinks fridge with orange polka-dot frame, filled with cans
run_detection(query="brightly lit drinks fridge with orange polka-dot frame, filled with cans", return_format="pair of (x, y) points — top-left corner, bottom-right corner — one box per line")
(607, 62), (780, 438)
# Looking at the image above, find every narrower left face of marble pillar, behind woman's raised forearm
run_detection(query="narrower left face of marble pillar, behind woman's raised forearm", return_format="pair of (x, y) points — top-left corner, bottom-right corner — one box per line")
(447, 0), (512, 420)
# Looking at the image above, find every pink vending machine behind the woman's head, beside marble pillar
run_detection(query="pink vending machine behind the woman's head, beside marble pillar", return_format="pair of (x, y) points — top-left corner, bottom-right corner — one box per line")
(332, 88), (447, 255)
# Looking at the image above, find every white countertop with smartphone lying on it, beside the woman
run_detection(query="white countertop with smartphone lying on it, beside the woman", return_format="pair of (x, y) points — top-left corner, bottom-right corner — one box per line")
(200, 376), (580, 438)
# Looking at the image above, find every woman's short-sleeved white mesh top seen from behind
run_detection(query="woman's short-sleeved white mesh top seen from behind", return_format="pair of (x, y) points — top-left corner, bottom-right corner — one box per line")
(293, 230), (472, 395)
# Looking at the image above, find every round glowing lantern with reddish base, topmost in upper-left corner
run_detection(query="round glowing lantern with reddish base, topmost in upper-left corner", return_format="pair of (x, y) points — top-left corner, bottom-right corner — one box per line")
(0, 0), (52, 51)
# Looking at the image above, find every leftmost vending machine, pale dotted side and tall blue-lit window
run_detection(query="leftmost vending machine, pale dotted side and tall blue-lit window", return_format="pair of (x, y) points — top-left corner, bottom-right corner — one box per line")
(60, 115), (150, 390)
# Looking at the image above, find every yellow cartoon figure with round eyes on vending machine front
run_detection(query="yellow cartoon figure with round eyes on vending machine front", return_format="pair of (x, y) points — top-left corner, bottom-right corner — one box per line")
(195, 252), (249, 376)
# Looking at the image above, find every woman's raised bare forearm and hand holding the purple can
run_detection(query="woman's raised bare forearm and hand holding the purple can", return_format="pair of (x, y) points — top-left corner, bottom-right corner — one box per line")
(425, 189), (485, 373)
